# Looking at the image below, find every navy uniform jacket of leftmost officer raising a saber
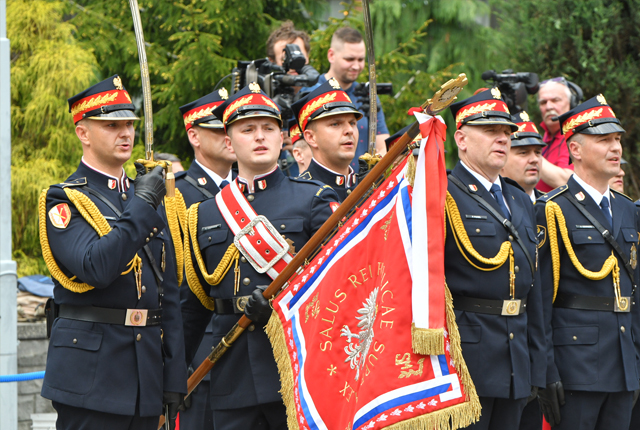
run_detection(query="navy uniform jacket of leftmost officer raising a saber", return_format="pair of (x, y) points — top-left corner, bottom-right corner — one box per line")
(42, 163), (187, 416)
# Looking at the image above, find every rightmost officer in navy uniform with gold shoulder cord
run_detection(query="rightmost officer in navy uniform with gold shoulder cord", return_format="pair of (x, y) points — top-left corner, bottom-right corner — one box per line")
(535, 94), (639, 430)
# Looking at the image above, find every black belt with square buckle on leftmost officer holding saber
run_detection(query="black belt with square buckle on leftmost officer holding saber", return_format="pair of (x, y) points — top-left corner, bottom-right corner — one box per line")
(58, 305), (162, 327)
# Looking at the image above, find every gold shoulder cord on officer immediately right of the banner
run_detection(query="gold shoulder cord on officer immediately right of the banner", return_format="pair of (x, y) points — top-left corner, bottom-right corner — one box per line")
(445, 191), (516, 299)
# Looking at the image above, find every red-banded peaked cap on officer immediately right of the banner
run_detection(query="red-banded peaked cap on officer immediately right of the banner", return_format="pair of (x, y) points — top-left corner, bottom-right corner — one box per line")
(449, 88), (518, 132)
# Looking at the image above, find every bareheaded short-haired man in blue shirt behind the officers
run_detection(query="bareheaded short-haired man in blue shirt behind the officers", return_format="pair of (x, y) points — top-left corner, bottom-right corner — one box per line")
(303, 27), (389, 171)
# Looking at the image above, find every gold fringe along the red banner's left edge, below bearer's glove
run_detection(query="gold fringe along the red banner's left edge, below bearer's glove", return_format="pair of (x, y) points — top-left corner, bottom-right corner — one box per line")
(264, 311), (300, 430)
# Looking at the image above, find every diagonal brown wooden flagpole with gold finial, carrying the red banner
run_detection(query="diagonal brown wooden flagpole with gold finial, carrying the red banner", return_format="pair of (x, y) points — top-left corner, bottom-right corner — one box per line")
(158, 73), (467, 428)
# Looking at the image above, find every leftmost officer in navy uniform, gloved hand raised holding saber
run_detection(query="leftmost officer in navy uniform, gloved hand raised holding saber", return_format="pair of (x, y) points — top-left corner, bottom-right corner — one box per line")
(39, 75), (187, 430)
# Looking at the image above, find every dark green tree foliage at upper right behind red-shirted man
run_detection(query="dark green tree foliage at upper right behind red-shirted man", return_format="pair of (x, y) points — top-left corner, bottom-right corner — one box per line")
(494, 0), (640, 197)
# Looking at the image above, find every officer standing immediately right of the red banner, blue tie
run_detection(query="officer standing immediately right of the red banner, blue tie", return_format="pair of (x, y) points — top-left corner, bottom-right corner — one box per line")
(445, 88), (546, 430)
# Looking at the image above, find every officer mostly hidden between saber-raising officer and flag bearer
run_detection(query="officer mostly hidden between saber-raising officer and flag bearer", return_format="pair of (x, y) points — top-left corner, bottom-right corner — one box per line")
(176, 88), (236, 430)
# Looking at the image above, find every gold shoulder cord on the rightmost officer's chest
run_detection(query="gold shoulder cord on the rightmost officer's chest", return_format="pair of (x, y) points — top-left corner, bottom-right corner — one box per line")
(545, 201), (628, 309)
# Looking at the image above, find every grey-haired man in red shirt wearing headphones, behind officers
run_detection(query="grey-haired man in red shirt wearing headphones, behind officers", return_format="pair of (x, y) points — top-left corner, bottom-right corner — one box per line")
(536, 77), (582, 192)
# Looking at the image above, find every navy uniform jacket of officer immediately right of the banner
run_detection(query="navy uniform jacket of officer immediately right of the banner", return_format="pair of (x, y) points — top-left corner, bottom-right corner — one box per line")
(445, 163), (546, 399)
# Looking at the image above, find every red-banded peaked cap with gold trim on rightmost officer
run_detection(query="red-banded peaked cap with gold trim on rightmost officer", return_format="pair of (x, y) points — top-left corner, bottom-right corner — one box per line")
(558, 94), (625, 139)
